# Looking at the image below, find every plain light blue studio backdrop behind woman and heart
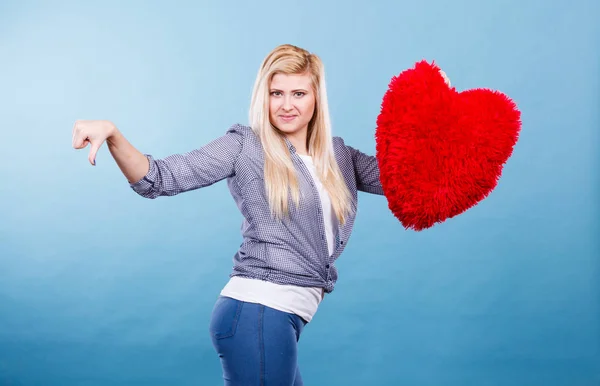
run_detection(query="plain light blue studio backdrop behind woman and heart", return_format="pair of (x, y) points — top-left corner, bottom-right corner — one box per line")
(0, 0), (600, 386)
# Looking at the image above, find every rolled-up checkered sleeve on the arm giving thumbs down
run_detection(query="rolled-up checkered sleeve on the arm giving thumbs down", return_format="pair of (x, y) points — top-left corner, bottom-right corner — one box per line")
(130, 128), (243, 199)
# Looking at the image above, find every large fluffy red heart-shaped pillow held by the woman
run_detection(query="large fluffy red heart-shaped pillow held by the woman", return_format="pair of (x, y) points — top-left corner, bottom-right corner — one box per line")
(375, 61), (521, 231)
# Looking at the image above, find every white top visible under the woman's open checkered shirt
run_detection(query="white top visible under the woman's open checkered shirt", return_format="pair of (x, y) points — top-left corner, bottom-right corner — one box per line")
(221, 155), (335, 322)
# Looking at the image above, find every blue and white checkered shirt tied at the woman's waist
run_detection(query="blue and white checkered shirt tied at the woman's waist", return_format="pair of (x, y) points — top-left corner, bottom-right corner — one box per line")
(130, 125), (383, 293)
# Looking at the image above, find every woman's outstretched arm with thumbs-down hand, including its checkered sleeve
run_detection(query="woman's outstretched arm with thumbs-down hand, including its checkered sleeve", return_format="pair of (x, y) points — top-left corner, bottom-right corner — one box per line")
(73, 121), (243, 198)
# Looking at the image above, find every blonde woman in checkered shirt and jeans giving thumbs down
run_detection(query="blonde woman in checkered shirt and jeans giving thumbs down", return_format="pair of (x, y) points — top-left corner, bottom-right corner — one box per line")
(73, 45), (446, 385)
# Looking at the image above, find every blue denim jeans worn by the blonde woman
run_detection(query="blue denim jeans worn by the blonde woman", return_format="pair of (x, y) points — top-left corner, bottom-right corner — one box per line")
(209, 296), (306, 386)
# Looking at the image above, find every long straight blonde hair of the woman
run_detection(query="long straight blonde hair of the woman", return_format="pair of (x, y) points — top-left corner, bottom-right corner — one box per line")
(249, 44), (352, 224)
